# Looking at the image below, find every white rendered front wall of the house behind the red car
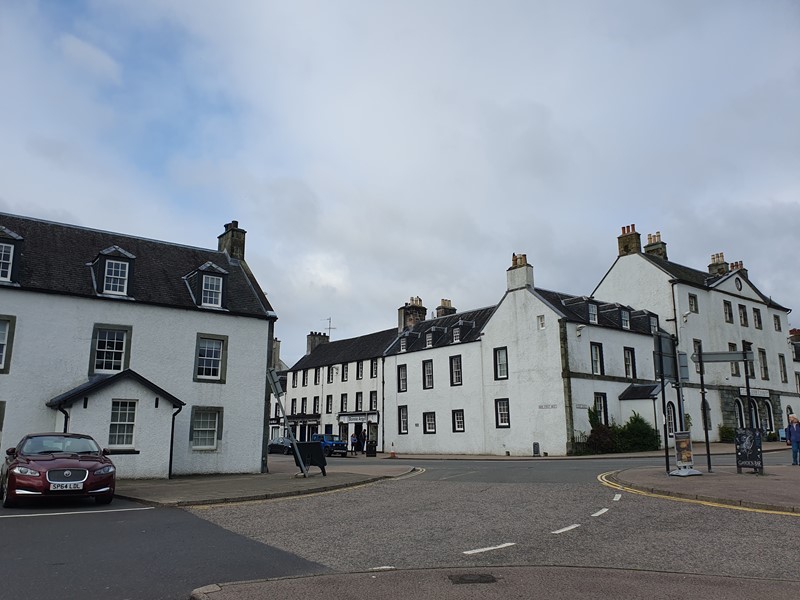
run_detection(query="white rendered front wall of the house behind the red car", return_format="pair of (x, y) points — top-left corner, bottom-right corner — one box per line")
(0, 290), (268, 474)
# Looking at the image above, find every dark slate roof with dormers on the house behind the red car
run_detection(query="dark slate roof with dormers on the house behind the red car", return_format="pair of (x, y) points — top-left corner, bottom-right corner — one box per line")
(0, 213), (276, 319)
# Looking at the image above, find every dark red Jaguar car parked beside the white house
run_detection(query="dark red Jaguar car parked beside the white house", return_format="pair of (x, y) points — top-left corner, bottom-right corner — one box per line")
(0, 433), (116, 508)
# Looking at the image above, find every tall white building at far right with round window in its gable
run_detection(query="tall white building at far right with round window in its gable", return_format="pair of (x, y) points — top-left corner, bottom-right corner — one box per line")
(594, 225), (800, 440)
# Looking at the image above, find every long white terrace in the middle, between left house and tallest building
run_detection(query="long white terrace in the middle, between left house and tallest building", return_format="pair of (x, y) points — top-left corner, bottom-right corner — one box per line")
(286, 255), (660, 456)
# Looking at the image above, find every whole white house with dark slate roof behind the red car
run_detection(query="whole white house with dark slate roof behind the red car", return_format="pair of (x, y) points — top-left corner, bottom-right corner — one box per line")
(0, 214), (276, 478)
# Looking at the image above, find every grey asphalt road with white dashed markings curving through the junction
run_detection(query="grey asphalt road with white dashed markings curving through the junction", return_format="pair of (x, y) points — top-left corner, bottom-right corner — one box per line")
(0, 457), (798, 600)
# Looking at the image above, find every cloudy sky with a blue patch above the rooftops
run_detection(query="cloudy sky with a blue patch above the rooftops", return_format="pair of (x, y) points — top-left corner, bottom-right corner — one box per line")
(0, 0), (800, 365)
